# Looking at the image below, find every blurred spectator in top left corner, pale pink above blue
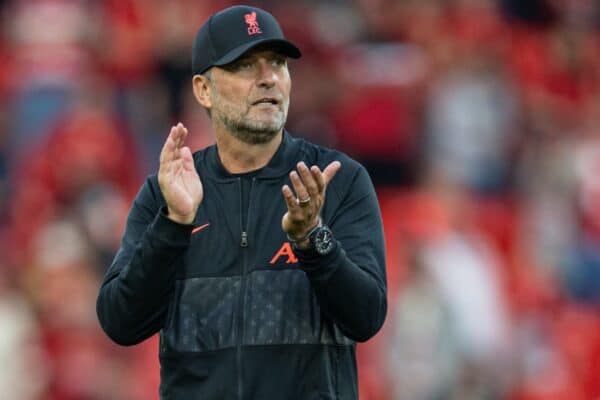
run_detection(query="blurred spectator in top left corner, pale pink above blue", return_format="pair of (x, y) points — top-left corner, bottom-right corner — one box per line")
(3, 0), (98, 159)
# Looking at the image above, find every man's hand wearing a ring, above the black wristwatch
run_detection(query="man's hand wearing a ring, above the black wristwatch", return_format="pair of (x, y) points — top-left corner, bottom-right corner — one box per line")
(281, 161), (342, 247)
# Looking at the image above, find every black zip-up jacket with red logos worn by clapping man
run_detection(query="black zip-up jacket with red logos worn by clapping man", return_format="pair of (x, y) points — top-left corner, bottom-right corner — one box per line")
(97, 133), (387, 400)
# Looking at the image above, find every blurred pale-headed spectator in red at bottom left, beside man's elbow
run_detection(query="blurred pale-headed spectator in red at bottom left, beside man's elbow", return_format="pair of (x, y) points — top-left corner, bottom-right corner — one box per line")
(22, 216), (152, 400)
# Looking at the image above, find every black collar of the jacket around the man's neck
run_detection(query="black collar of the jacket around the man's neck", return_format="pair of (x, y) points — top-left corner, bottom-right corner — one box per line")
(199, 130), (302, 180)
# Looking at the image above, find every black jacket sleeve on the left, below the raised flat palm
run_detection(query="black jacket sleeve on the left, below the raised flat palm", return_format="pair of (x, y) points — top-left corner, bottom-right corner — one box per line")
(96, 178), (192, 345)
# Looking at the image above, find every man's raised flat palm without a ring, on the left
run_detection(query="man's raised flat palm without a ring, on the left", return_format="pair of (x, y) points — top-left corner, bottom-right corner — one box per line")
(158, 122), (203, 224)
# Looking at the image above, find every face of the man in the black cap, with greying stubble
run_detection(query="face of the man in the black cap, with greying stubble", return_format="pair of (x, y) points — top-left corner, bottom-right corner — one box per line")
(209, 50), (291, 144)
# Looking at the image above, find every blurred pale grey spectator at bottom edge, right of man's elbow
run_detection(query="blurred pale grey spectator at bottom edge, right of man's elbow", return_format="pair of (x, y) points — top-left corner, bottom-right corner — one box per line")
(385, 244), (461, 400)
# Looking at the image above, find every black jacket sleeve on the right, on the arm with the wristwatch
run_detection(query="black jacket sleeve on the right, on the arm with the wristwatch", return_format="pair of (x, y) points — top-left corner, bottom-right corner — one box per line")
(296, 166), (387, 342)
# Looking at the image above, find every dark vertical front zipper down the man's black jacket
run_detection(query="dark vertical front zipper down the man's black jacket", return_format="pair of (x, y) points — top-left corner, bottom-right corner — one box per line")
(236, 178), (255, 400)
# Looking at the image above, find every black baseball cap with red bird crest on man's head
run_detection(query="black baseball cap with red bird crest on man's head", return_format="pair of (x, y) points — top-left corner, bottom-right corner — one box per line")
(192, 6), (301, 74)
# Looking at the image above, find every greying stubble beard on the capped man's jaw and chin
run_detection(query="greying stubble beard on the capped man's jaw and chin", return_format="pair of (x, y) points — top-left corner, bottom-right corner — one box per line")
(212, 90), (289, 144)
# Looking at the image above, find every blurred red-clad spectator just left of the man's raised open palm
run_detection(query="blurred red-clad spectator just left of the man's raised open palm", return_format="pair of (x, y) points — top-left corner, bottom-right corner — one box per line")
(10, 103), (139, 259)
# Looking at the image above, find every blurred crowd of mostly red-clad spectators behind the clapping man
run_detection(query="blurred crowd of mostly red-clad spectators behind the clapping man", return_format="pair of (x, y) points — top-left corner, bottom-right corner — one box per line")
(0, 0), (600, 400)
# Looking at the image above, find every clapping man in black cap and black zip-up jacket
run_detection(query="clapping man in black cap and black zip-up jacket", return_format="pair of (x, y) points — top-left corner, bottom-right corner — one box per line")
(97, 6), (387, 400)
